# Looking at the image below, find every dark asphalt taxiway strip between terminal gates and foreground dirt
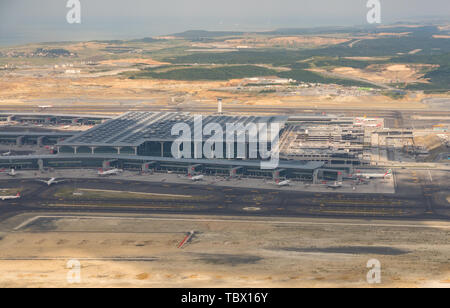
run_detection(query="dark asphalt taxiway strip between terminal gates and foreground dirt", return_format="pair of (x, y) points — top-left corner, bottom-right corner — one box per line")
(0, 178), (450, 221)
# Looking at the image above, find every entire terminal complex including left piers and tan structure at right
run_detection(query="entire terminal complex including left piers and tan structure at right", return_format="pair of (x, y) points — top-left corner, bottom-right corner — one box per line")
(0, 111), (376, 182)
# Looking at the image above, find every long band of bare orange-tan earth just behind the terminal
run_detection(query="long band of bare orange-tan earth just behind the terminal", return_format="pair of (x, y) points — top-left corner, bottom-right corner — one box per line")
(0, 76), (440, 113)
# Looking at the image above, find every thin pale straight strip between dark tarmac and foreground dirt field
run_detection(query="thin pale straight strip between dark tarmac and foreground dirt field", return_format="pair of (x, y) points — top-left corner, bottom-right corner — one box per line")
(14, 215), (450, 231)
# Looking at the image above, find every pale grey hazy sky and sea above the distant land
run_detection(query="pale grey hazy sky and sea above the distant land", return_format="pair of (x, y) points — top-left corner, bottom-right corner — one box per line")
(0, 0), (450, 45)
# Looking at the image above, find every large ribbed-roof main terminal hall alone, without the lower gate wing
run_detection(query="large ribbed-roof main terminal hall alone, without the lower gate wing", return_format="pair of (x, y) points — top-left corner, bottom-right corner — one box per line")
(57, 112), (288, 159)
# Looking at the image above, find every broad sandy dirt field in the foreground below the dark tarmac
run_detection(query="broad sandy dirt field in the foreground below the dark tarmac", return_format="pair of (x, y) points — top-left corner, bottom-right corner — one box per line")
(0, 214), (450, 287)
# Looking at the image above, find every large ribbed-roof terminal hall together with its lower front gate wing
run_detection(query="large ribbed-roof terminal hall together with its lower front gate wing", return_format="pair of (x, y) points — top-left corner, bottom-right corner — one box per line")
(52, 112), (336, 180)
